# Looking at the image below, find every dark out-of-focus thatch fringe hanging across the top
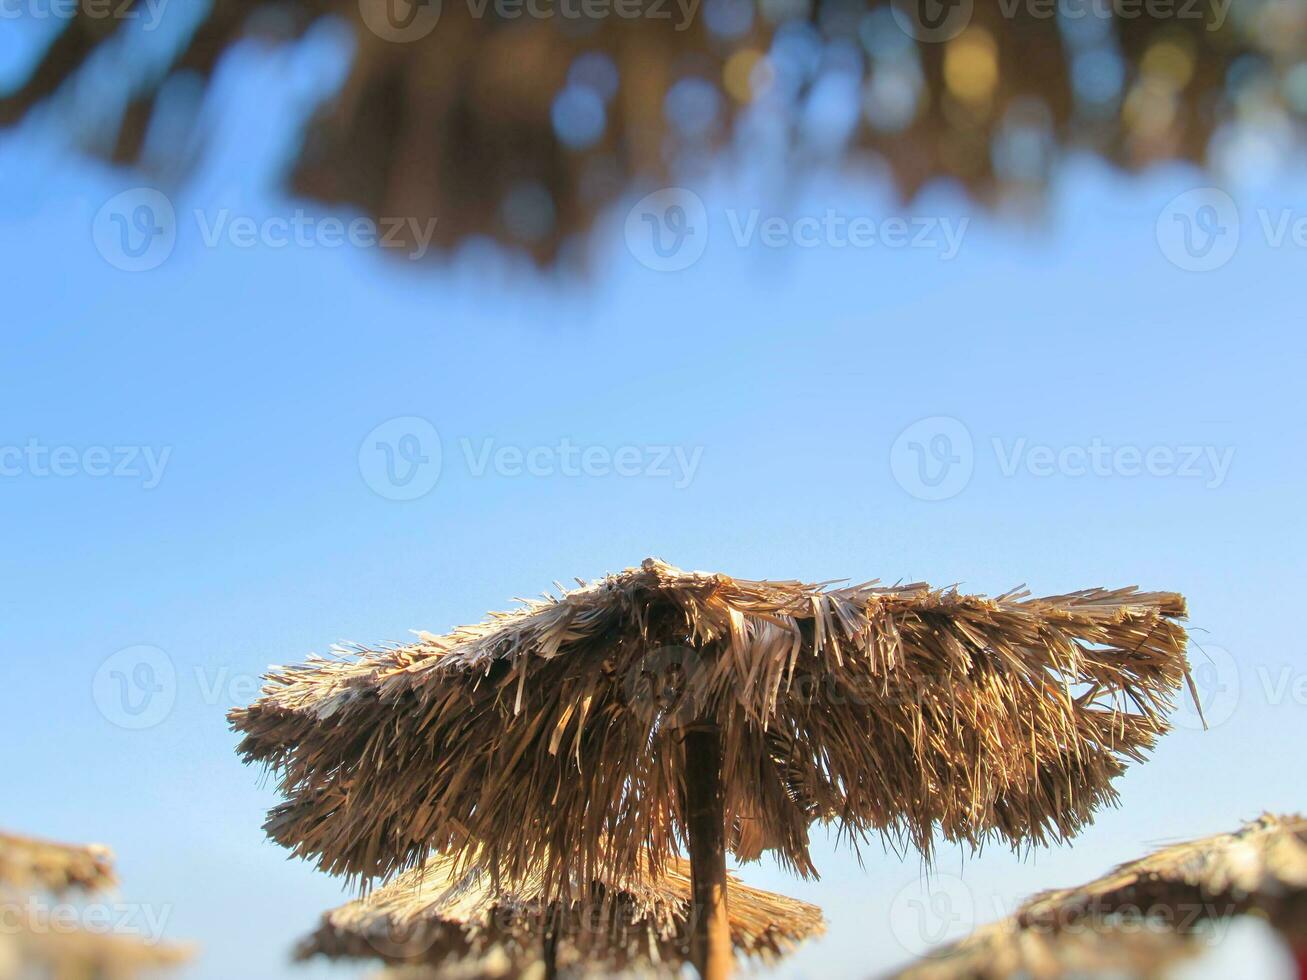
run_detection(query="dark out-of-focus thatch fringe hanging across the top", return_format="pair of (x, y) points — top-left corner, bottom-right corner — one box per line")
(0, 0), (1307, 260)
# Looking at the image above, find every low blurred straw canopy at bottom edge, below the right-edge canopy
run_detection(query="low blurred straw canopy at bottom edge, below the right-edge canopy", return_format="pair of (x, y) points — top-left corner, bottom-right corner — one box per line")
(893, 919), (1197, 980)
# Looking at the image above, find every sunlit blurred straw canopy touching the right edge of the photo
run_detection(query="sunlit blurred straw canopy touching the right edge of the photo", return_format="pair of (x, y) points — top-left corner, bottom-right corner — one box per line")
(1019, 814), (1307, 942)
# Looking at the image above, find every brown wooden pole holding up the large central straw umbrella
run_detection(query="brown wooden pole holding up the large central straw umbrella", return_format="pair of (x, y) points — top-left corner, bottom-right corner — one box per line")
(685, 724), (735, 980)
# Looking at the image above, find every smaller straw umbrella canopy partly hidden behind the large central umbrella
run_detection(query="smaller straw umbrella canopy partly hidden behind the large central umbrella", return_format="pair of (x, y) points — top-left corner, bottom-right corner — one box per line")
(297, 856), (825, 976)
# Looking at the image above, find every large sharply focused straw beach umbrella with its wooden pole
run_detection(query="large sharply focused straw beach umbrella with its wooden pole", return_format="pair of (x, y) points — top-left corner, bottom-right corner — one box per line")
(231, 559), (1188, 977)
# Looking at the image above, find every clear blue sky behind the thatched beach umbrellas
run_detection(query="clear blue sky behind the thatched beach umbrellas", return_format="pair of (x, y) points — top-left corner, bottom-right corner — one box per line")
(0, 26), (1307, 980)
